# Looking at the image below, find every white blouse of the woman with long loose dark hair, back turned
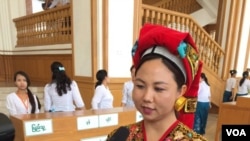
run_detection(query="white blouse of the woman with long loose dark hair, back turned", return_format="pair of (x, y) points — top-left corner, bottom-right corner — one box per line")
(44, 81), (84, 111)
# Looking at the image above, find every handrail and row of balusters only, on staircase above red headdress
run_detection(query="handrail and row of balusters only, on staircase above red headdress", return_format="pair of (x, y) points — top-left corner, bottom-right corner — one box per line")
(141, 4), (225, 74)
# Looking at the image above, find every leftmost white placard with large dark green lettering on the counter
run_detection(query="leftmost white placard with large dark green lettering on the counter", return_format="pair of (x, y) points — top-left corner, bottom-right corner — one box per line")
(24, 119), (53, 136)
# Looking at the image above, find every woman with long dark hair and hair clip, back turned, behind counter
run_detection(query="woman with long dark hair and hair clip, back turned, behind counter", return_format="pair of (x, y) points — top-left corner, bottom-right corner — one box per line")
(44, 62), (85, 112)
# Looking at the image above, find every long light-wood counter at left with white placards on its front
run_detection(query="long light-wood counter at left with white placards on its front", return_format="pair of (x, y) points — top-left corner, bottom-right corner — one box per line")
(10, 107), (138, 141)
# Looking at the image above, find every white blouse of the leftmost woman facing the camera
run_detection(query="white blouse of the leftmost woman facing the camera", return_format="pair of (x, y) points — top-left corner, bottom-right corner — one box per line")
(6, 92), (39, 115)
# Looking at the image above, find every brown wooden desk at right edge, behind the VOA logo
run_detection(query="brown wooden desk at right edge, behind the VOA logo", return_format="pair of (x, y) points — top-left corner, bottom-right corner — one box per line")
(215, 96), (250, 141)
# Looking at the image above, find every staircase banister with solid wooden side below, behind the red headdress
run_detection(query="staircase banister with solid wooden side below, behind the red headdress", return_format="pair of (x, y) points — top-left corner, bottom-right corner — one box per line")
(140, 4), (225, 106)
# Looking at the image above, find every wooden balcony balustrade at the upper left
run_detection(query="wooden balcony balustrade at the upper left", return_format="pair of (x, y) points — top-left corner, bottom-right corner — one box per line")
(13, 5), (72, 47)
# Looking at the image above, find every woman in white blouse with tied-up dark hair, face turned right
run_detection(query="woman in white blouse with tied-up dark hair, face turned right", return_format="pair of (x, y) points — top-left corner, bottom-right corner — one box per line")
(91, 69), (114, 110)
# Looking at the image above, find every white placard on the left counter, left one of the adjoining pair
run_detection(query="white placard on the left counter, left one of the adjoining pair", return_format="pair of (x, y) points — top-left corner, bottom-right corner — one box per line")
(77, 116), (99, 130)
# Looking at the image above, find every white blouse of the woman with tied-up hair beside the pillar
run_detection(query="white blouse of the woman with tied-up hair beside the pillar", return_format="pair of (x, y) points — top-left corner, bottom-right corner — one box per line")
(91, 85), (114, 110)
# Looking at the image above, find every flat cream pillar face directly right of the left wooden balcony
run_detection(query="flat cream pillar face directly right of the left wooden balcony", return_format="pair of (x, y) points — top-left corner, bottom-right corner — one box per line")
(72, 0), (92, 76)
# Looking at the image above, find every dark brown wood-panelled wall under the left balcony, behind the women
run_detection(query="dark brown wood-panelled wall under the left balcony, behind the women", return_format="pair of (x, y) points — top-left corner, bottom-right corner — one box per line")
(12, 54), (73, 86)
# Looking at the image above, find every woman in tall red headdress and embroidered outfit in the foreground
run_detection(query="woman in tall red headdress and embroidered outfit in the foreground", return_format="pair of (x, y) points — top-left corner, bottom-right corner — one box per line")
(107, 24), (206, 141)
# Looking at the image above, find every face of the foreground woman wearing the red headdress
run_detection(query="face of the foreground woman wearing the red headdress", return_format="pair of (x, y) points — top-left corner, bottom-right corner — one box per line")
(133, 59), (186, 121)
